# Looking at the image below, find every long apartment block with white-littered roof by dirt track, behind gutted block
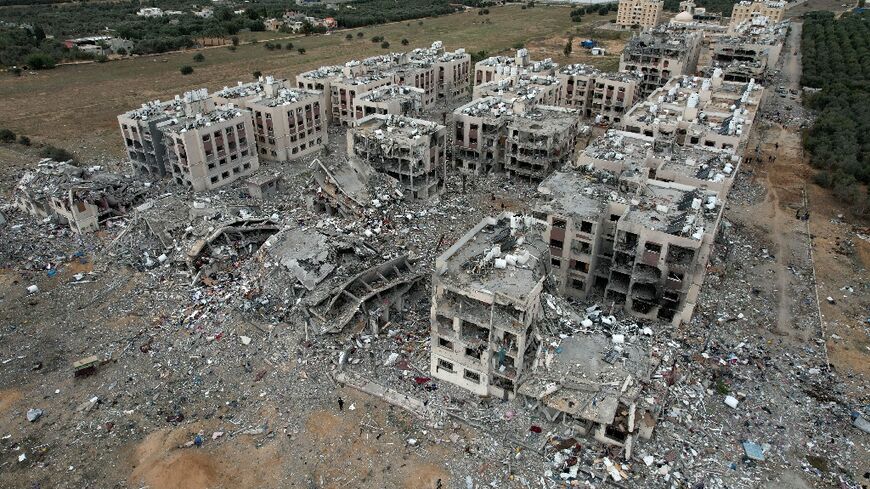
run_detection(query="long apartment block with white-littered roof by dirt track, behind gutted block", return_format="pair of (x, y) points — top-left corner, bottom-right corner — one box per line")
(622, 69), (764, 154)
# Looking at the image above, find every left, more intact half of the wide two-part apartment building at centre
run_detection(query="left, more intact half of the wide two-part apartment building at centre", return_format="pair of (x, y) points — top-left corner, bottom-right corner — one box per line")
(453, 97), (513, 175)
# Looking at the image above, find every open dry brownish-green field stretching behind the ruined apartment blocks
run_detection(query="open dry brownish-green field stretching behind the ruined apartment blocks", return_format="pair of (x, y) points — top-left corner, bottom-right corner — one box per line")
(0, 5), (612, 158)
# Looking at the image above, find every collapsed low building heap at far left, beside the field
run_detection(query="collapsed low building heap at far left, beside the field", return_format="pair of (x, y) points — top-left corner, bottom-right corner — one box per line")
(13, 160), (148, 233)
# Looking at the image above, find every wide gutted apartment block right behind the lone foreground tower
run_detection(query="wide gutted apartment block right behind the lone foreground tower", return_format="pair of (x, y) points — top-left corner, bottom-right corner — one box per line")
(535, 168), (723, 324)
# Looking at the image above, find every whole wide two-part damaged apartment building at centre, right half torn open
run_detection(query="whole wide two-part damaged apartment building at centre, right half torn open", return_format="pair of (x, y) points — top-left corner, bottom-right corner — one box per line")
(453, 97), (588, 180)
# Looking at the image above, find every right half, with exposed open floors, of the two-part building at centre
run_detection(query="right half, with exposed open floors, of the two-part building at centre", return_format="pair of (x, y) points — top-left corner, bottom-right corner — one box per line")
(502, 105), (580, 180)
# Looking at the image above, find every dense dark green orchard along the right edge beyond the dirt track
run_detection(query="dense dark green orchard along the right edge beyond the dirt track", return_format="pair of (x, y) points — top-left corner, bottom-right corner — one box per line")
(801, 12), (870, 213)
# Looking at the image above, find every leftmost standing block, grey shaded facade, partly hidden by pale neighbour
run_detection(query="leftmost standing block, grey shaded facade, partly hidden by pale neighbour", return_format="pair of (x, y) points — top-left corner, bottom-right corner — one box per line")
(118, 100), (180, 178)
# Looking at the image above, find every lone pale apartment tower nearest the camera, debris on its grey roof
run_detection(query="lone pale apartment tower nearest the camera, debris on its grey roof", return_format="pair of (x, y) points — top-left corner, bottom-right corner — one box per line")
(430, 213), (548, 399)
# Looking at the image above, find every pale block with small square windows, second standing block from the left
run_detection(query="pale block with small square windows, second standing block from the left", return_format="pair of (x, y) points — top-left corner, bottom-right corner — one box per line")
(161, 89), (260, 191)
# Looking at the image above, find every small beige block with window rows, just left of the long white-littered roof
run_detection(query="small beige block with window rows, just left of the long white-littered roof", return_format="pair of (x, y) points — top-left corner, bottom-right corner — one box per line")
(556, 64), (641, 123)
